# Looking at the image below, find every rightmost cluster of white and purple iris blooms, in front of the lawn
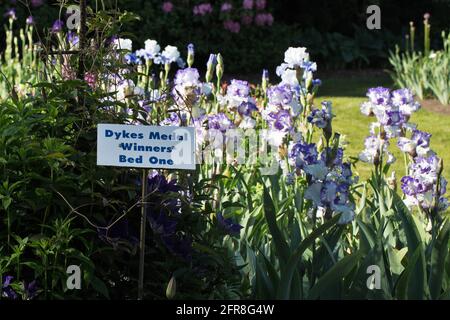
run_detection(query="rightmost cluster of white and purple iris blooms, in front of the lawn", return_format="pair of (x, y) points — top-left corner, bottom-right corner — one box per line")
(359, 87), (448, 217)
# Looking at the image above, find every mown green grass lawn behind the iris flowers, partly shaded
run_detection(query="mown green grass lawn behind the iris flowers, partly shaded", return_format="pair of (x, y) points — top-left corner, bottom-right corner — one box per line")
(319, 75), (450, 179)
